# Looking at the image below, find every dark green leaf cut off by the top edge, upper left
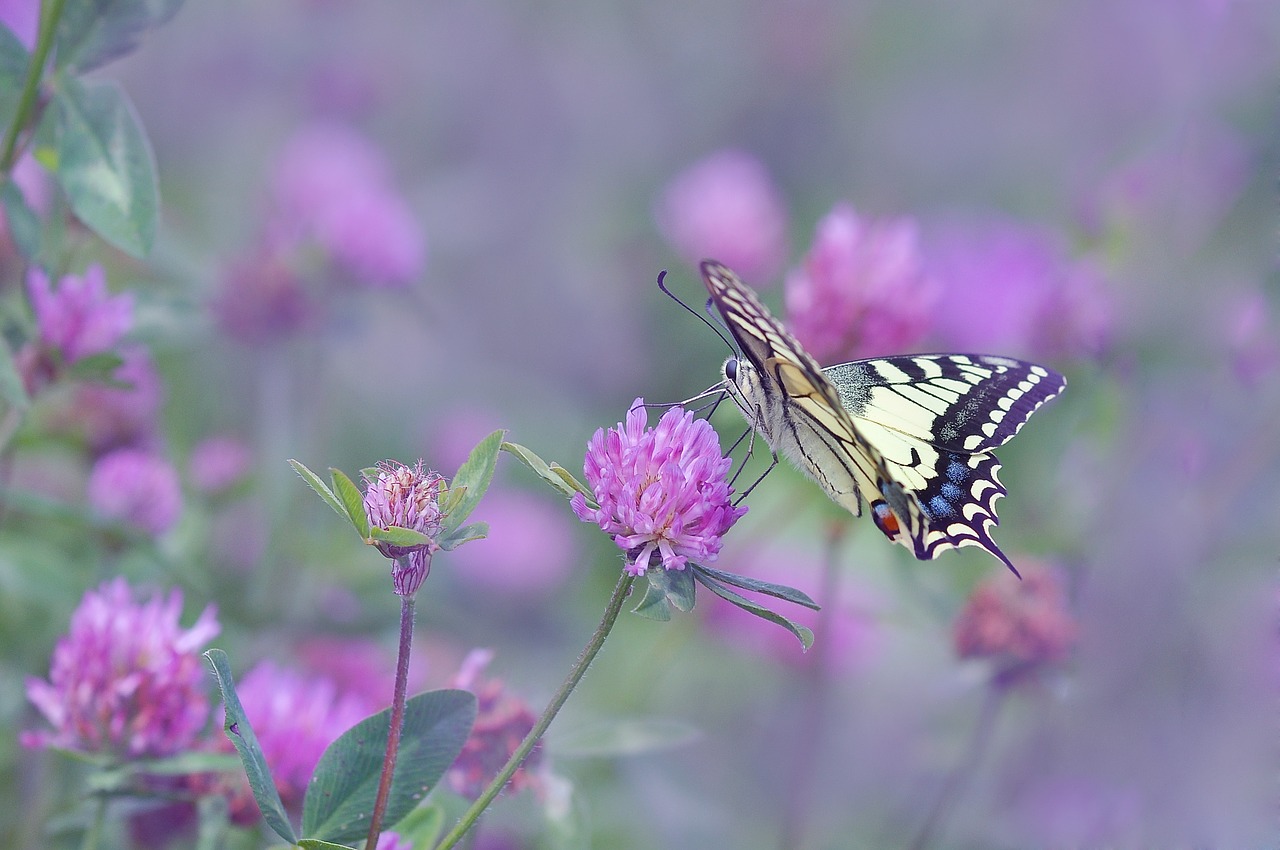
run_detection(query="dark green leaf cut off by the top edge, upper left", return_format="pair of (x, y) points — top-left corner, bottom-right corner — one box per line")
(54, 0), (182, 73)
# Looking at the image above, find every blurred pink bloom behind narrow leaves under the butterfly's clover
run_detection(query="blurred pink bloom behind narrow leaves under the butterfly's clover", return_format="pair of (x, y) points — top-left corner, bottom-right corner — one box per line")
(704, 545), (877, 672)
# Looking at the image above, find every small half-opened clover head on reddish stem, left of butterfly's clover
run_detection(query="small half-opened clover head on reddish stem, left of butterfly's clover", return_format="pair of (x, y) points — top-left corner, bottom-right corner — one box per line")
(365, 461), (444, 597)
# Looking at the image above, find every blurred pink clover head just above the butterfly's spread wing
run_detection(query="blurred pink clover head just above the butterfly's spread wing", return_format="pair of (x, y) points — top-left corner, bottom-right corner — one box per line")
(786, 204), (938, 364)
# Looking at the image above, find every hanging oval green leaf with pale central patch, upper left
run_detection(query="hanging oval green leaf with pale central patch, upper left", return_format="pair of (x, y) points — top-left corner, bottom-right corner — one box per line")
(52, 77), (160, 257)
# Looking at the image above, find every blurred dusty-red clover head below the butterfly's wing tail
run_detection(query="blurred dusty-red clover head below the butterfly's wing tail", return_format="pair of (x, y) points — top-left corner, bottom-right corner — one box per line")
(954, 566), (1078, 673)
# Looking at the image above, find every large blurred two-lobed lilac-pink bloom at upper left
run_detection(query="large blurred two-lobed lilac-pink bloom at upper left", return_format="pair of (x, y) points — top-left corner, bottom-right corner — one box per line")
(271, 123), (426, 287)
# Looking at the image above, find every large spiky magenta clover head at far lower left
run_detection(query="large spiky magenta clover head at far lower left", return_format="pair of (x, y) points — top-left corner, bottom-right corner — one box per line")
(22, 579), (220, 758)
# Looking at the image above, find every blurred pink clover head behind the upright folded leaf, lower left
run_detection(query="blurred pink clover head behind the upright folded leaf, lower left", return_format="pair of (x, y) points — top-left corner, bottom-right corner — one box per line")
(218, 661), (376, 823)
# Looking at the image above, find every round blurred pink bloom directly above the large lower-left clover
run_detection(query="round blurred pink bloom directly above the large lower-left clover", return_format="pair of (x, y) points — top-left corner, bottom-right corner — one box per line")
(88, 448), (182, 535)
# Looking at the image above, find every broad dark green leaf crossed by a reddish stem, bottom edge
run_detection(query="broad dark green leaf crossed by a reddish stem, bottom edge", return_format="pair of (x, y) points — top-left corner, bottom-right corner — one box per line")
(302, 690), (476, 841)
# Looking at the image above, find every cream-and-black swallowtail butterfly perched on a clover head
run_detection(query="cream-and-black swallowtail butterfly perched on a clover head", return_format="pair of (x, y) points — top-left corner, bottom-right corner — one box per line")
(701, 260), (1066, 575)
